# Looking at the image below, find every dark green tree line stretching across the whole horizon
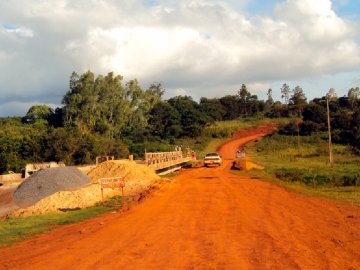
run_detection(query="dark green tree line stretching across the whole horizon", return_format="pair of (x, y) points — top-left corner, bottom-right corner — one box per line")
(0, 71), (360, 173)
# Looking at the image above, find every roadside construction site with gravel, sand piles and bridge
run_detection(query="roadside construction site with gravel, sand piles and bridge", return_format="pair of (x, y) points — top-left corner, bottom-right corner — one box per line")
(0, 151), (193, 217)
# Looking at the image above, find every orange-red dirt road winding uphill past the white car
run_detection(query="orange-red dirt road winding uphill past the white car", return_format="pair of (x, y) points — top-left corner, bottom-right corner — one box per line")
(0, 127), (360, 270)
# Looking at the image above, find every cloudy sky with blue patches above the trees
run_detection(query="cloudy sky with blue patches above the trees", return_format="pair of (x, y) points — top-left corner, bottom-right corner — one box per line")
(0, 0), (360, 116)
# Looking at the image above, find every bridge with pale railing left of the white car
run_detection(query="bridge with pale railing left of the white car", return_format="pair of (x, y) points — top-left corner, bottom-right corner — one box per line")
(145, 150), (195, 174)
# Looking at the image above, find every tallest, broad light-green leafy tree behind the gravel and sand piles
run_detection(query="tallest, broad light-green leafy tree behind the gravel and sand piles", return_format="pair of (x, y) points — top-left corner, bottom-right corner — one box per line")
(62, 71), (134, 138)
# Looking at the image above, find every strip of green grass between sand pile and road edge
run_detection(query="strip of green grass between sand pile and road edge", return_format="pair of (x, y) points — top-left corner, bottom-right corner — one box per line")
(0, 196), (130, 247)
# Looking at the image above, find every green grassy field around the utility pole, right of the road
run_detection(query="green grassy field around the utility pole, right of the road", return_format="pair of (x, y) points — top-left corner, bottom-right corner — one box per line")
(247, 133), (360, 204)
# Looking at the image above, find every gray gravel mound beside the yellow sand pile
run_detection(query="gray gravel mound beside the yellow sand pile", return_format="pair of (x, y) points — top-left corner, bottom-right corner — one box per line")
(13, 167), (91, 208)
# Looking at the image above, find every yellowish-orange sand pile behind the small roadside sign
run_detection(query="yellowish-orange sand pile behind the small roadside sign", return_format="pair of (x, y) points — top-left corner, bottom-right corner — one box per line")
(12, 160), (160, 216)
